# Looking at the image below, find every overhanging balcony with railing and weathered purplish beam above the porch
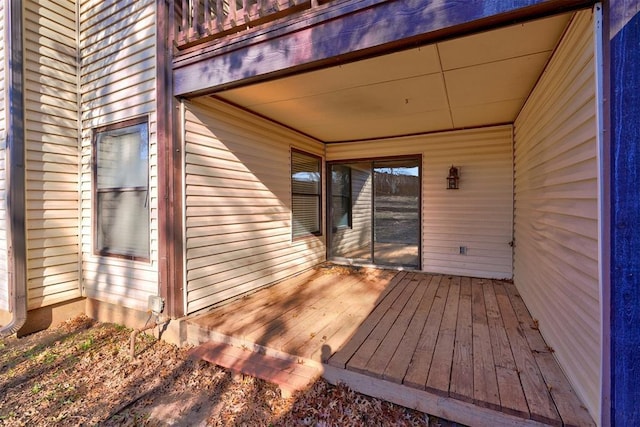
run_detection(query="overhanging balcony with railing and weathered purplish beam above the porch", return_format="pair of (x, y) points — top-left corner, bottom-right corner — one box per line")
(169, 0), (589, 98)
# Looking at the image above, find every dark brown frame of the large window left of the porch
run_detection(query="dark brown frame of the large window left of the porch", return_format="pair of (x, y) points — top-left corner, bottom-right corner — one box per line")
(91, 116), (151, 263)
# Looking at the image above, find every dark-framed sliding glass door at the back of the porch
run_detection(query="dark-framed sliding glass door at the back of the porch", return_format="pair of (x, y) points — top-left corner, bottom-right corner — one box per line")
(328, 159), (420, 267)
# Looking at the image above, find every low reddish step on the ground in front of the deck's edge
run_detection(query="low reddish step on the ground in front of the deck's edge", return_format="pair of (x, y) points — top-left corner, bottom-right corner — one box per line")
(189, 342), (321, 397)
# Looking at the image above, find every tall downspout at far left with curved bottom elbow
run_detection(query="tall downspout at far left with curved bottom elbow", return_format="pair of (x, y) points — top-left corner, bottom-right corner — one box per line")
(0, 0), (27, 337)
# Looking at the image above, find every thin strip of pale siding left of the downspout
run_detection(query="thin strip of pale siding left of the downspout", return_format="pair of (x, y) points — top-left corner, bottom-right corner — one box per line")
(0, 2), (9, 311)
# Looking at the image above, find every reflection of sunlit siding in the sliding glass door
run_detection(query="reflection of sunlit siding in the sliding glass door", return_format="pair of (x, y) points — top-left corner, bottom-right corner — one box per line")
(331, 163), (373, 258)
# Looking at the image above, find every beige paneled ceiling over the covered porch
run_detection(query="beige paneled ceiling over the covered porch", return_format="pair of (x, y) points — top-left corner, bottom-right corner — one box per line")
(216, 14), (572, 142)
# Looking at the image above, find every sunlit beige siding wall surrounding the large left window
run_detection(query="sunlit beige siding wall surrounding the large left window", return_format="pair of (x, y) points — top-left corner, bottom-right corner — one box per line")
(80, 0), (158, 310)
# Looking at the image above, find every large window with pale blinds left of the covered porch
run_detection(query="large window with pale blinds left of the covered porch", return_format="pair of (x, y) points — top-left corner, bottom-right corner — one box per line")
(93, 118), (150, 260)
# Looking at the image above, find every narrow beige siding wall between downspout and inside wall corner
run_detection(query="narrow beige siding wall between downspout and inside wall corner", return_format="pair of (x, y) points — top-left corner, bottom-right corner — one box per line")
(23, 0), (81, 309)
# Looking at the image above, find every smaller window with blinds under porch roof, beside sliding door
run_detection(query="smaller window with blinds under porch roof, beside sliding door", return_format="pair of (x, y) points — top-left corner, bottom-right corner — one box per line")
(291, 150), (322, 238)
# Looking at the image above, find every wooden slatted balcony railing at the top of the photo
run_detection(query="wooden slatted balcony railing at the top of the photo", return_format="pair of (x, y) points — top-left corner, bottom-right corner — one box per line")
(174, 0), (320, 49)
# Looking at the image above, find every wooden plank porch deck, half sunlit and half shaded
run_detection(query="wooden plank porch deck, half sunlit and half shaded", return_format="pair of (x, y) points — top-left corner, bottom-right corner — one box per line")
(190, 267), (593, 426)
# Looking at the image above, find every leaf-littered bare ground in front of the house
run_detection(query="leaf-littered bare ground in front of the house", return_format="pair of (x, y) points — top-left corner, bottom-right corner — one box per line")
(0, 317), (454, 426)
